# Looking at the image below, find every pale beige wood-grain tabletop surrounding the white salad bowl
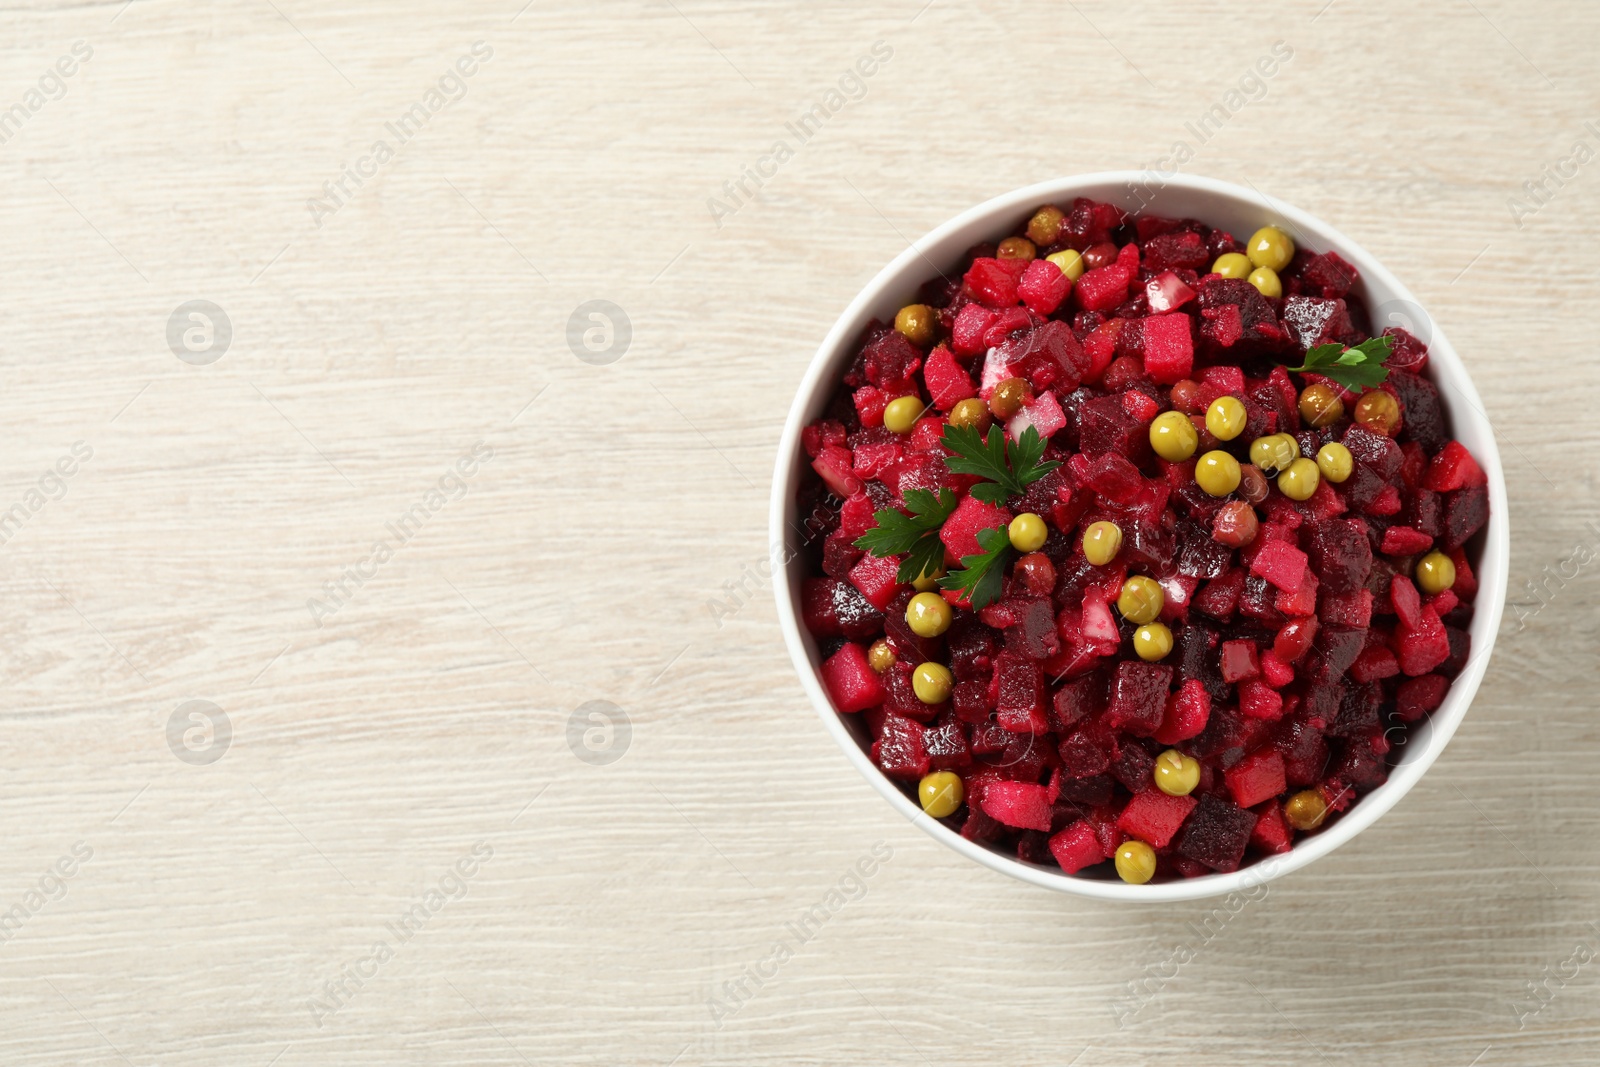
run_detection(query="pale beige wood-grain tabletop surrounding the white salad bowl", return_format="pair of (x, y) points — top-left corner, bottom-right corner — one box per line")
(0, 0), (1600, 1067)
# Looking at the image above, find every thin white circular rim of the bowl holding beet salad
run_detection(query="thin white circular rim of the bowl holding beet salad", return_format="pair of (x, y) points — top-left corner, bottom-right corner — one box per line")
(768, 170), (1510, 904)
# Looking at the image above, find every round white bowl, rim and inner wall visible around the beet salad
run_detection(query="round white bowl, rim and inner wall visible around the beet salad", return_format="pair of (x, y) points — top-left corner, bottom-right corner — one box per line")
(771, 171), (1510, 902)
